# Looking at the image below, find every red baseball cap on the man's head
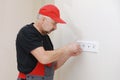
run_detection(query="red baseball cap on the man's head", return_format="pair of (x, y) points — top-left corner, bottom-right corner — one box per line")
(39, 4), (66, 24)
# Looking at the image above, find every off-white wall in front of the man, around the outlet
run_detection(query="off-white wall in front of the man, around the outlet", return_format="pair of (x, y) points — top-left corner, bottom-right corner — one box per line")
(53, 0), (120, 80)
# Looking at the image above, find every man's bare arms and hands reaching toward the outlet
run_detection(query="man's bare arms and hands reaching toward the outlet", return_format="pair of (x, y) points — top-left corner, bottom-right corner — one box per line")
(31, 43), (81, 64)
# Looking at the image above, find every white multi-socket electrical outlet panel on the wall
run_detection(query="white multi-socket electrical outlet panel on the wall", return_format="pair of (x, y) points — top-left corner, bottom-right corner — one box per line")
(77, 40), (98, 52)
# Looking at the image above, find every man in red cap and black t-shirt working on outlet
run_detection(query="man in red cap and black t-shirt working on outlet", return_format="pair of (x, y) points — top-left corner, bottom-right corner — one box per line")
(16, 4), (81, 80)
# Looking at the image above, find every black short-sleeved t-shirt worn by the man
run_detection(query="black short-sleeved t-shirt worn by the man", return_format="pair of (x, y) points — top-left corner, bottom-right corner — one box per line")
(16, 23), (53, 74)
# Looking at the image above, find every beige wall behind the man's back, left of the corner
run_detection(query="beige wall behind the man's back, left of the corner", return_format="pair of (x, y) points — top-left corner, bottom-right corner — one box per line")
(0, 0), (53, 80)
